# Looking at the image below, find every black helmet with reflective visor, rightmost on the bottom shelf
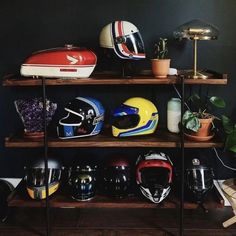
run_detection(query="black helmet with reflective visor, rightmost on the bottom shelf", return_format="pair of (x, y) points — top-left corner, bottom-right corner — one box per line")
(186, 158), (214, 203)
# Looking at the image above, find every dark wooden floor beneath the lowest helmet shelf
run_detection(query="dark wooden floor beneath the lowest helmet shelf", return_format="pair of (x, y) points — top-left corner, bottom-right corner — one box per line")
(0, 207), (236, 236)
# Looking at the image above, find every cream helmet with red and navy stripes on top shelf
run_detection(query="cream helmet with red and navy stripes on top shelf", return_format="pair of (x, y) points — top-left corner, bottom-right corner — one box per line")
(99, 20), (145, 60)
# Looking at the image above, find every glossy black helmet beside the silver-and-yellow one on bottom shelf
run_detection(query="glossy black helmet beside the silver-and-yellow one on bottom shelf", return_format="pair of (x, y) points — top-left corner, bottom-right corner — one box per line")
(68, 164), (97, 201)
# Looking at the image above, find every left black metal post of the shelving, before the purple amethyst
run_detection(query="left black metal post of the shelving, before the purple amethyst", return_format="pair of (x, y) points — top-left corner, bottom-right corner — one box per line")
(42, 77), (50, 236)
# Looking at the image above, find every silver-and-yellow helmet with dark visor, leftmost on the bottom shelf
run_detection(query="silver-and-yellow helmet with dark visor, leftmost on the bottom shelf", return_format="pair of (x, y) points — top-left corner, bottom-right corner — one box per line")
(25, 158), (61, 200)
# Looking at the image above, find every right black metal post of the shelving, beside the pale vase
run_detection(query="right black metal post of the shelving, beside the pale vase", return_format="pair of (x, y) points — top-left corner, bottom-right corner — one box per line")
(179, 76), (185, 236)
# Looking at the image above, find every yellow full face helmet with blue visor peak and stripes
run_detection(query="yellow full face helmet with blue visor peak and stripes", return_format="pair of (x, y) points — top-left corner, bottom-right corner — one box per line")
(112, 97), (159, 137)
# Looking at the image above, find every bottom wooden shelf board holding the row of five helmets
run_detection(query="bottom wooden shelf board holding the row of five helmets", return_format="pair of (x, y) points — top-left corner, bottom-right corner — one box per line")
(8, 180), (224, 209)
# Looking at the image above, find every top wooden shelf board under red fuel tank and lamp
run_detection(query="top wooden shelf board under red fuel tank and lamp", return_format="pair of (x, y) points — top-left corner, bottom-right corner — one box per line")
(3, 74), (228, 86)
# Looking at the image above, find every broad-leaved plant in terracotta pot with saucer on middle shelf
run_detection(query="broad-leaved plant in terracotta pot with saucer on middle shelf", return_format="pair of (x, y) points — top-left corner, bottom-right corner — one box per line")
(182, 94), (225, 141)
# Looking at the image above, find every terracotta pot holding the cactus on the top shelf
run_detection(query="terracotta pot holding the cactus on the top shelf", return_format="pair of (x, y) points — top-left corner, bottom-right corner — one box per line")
(151, 59), (170, 78)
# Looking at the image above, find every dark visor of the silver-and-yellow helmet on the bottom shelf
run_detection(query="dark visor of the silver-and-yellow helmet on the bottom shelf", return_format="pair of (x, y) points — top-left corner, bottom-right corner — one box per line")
(26, 168), (61, 187)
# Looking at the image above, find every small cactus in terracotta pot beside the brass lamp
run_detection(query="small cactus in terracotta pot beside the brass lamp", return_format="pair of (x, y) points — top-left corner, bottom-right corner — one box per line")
(151, 38), (170, 78)
